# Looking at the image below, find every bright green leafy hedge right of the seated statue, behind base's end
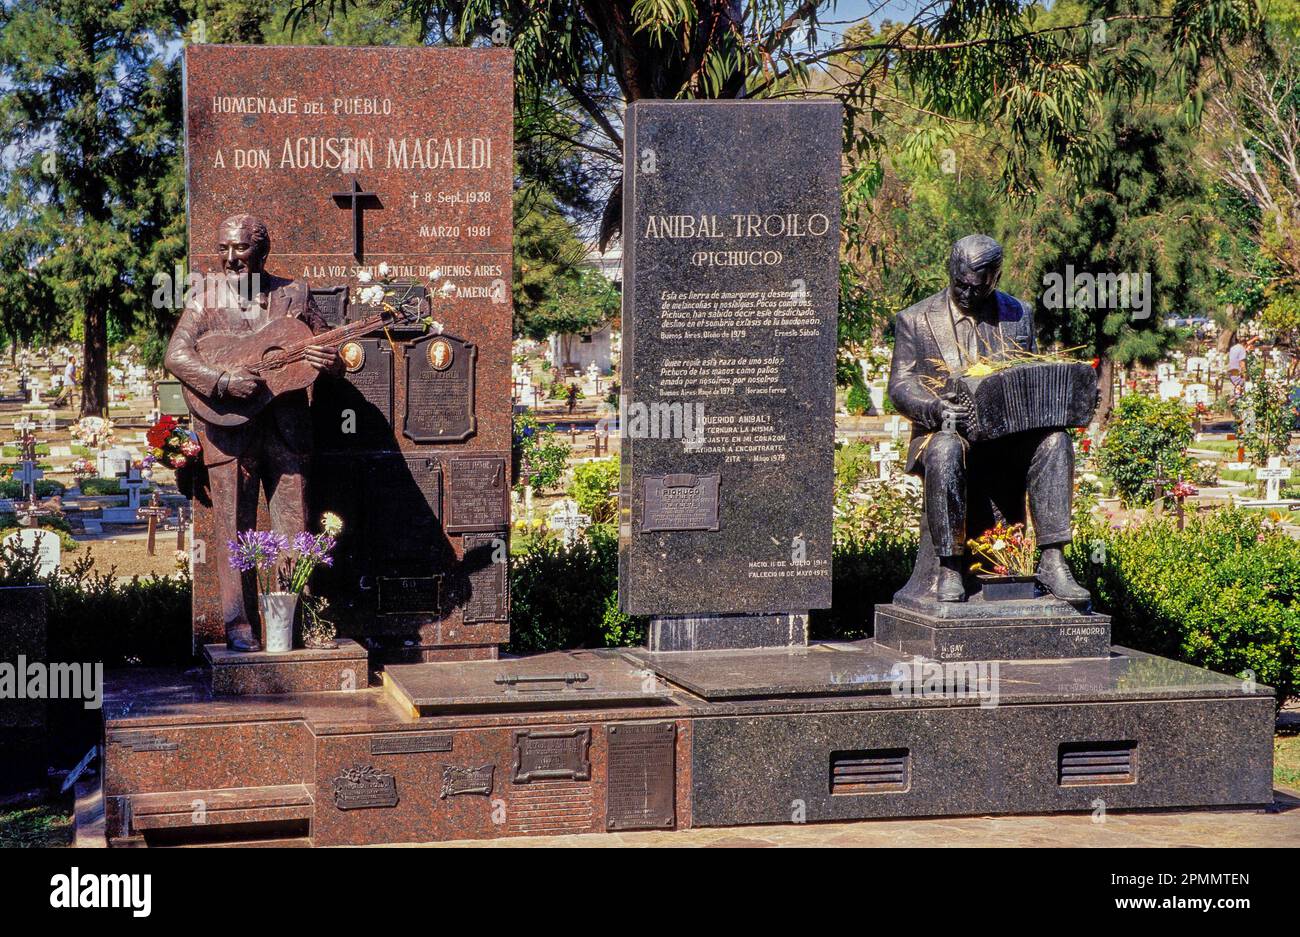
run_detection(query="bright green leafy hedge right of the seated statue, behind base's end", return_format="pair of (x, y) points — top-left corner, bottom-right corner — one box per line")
(1070, 508), (1300, 706)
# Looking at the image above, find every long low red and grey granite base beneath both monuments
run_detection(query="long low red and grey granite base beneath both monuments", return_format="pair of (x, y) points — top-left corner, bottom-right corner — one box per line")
(94, 642), (1274, 845)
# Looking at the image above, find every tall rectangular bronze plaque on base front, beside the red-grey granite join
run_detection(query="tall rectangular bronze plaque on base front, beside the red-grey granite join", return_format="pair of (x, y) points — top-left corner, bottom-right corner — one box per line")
(605, 723), (677, 829)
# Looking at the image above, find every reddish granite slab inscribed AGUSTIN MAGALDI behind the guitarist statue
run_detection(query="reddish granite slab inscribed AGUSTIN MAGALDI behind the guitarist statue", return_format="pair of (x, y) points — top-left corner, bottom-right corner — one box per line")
(185, 45), (514, 659)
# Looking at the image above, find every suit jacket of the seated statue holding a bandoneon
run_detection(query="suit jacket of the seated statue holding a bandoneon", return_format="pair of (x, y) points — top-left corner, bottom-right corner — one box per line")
(889, 289), (1037, 474)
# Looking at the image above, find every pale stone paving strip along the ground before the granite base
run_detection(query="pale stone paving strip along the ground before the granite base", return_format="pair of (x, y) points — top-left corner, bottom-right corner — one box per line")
(429, 788), (1300, 849)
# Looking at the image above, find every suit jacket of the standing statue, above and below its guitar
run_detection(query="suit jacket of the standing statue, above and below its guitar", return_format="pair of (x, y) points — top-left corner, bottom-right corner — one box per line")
(165, 273), (328, 465)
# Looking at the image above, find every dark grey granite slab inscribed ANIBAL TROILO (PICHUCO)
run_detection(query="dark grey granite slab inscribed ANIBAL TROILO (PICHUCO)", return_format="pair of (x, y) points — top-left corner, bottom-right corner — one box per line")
(619, 101), (841, 639)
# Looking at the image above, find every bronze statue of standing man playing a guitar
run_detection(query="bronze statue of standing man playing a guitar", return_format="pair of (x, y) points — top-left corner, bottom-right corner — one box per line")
(166, 214), (343, 651)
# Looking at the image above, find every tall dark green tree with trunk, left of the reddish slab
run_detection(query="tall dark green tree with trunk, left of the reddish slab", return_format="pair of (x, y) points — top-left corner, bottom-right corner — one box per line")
(0, 0), (187, 415)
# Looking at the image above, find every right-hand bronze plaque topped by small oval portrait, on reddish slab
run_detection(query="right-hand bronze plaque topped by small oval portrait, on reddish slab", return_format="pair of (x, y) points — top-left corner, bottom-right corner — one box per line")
(402, 335), (478, 443)
